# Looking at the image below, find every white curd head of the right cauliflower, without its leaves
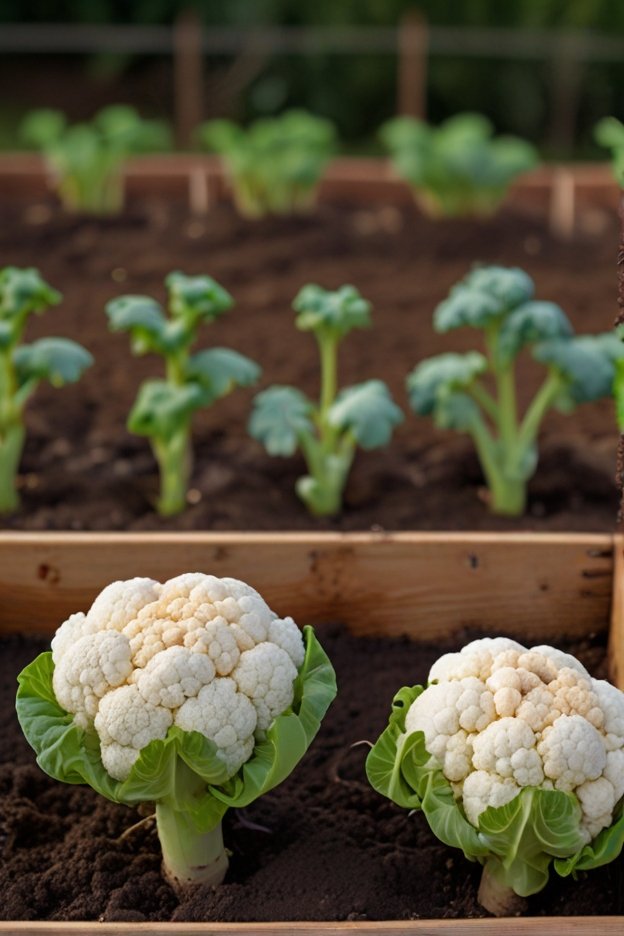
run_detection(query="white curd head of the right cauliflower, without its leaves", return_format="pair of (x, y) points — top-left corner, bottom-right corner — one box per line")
(404, 637), (624, 842)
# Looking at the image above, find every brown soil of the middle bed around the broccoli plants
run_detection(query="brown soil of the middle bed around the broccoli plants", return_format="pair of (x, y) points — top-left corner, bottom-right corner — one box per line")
(0, 198), (618, 531)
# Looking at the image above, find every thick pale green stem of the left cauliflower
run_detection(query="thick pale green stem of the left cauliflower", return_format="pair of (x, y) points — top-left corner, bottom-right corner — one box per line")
(156, 803), (228, 893)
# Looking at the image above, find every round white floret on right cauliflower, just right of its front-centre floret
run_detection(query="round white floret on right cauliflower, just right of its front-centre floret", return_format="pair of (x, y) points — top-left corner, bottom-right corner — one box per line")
(537, 715), (607, 791)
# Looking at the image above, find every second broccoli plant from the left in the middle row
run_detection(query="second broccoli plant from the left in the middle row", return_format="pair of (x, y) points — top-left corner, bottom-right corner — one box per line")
(106, 273), (260, 517)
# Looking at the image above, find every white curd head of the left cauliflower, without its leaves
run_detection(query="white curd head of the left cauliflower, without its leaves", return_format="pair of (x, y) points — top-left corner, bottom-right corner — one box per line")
(52, 573), (304, 780)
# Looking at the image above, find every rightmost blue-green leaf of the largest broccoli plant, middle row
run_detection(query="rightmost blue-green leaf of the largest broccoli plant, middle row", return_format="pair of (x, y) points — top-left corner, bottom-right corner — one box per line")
(533, 333), (624, 411)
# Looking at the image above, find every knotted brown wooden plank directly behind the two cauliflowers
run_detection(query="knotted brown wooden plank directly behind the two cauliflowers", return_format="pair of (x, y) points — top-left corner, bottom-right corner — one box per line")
(0, 533), (613, 642)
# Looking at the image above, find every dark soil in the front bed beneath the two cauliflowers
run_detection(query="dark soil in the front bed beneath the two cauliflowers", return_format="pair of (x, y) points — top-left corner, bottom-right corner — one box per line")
(0, 628), (624, 922)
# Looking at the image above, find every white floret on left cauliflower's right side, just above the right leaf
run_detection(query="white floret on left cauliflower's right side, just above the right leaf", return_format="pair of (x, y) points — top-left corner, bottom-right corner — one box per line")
(232, 643), (297, 731)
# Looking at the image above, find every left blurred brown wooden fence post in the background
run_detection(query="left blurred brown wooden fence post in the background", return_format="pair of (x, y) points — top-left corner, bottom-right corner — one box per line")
(173, 9), (203, 149)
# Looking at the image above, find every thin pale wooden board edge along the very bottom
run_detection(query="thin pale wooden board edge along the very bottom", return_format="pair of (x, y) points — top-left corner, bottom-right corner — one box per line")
(0, 917), (624, 936)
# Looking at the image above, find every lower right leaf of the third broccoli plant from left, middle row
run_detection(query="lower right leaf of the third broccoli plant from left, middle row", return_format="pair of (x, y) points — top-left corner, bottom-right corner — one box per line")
(327, 380), (404, 450)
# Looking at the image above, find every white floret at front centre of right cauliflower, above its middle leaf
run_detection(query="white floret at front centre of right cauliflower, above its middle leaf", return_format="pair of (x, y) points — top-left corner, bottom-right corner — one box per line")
(472, 718), (544, 786)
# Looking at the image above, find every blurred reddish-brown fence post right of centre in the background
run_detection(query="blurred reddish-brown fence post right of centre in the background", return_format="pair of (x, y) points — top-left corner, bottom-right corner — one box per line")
(397, 10), (428, 120)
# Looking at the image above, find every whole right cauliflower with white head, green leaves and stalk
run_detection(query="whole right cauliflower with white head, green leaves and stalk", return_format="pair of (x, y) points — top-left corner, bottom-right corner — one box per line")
(366, 637), (624, 915)
